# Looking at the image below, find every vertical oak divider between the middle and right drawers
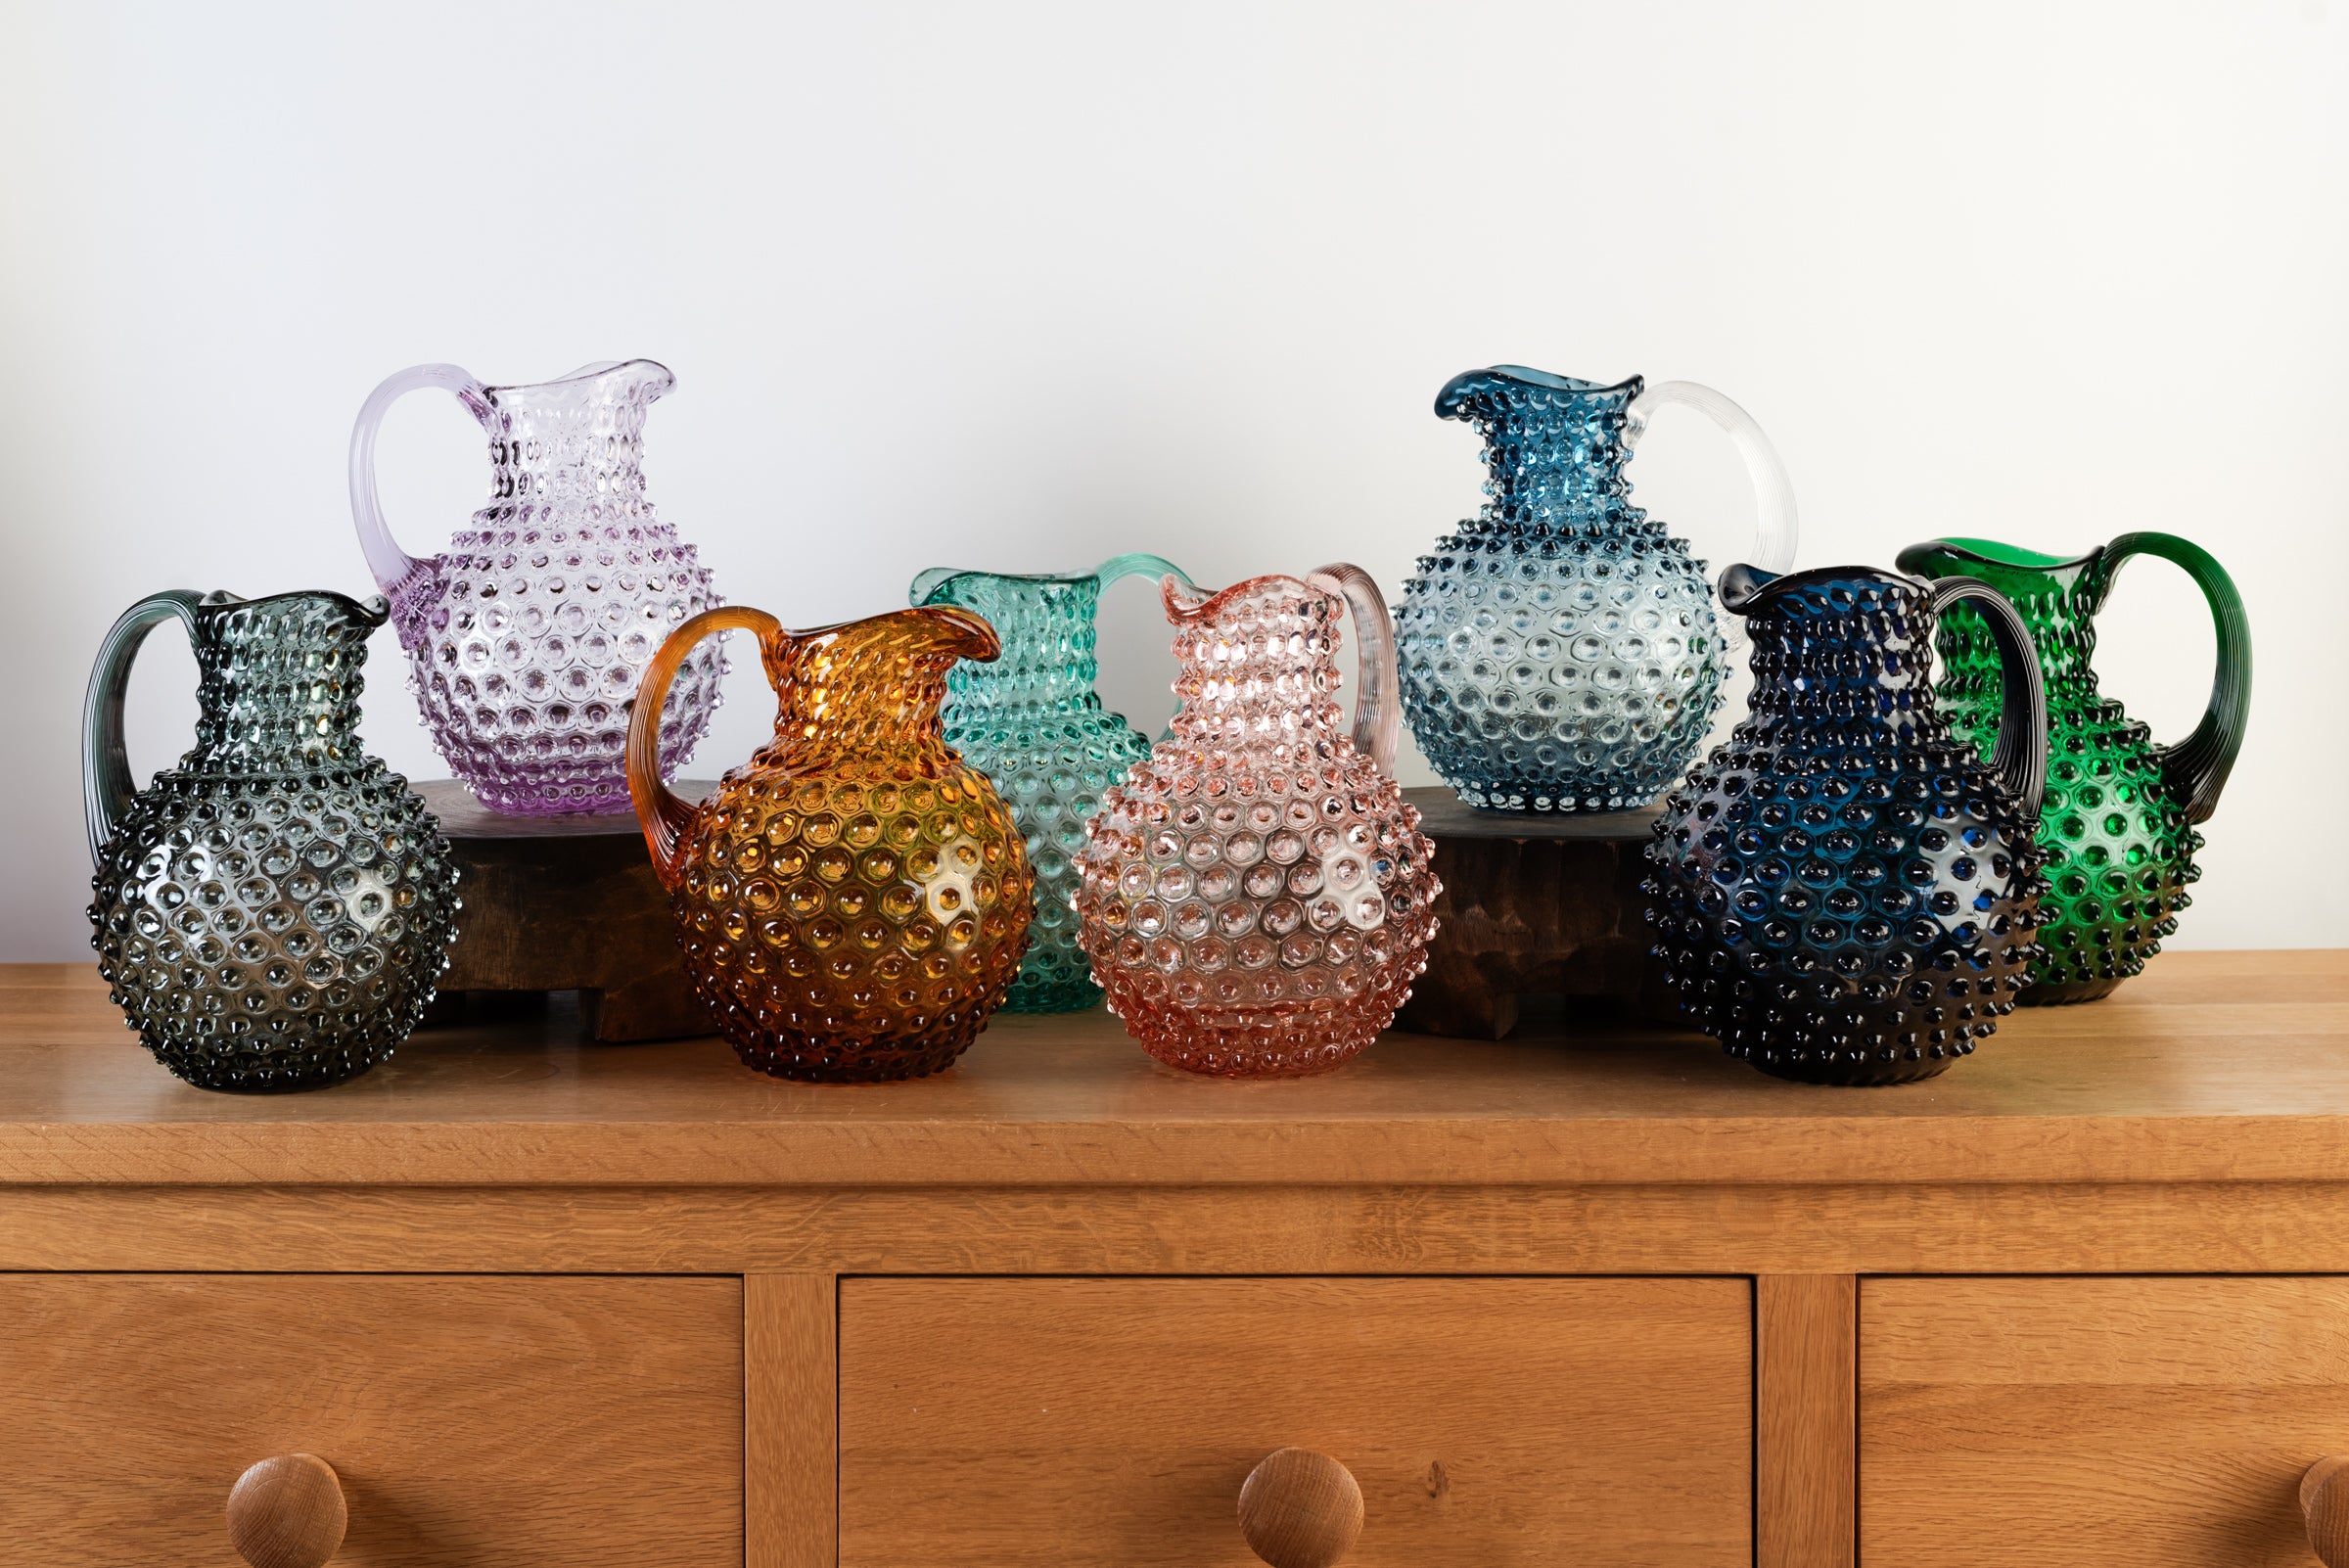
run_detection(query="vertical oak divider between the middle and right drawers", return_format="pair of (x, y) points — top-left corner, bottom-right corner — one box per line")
(1755, 1274), (1861, 1568)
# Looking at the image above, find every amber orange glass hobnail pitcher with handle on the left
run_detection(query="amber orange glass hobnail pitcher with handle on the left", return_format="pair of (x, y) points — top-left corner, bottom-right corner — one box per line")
(627, 606), (1036, 1083)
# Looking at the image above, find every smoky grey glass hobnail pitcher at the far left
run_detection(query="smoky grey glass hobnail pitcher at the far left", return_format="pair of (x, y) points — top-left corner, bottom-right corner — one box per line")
(84, 594), (458, 1089)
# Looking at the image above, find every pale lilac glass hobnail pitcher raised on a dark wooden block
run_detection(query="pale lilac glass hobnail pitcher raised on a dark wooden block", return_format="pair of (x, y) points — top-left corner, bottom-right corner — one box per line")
(350, 359), (726, 817)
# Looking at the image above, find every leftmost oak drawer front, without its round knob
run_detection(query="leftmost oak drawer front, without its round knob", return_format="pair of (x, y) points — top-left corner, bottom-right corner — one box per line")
(0, 1274), (742, 1568)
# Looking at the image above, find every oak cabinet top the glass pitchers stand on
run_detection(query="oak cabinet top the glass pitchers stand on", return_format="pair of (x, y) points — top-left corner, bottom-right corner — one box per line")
(0, 950), (2349, 1187)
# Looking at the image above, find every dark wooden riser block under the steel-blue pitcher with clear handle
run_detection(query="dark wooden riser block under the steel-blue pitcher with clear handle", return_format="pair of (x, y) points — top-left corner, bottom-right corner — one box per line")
(1396, 786), (1675, 1039)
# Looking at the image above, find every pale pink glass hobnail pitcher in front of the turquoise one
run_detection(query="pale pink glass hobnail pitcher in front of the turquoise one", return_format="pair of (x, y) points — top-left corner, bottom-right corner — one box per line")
(1076, 566), (1443, 1078)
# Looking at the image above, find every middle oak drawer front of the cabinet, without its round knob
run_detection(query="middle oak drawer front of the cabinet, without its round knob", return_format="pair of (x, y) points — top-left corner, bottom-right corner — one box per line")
(839, 1279), (1752, 1568)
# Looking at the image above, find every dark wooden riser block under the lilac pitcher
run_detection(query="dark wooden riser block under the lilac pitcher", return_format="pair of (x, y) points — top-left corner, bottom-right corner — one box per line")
(413, 779), (712, 1042)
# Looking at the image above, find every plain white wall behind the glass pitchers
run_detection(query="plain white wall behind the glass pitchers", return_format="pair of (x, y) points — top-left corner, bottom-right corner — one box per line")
(0, 0), (2349, 960)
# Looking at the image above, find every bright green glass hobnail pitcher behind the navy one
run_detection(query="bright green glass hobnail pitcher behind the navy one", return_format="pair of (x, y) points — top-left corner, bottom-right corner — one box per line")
(1901, 532), (2250, 1004)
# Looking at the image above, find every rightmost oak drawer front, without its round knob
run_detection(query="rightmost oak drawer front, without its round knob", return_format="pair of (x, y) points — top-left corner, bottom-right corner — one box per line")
(1861, 1277), (2349, 1568)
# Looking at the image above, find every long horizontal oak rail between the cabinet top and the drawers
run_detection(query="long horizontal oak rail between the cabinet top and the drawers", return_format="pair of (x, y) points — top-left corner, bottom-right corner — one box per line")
(23, 1183), (2349, 1274)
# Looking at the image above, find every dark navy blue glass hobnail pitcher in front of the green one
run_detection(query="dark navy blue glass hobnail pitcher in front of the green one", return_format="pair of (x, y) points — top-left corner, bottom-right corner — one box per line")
(1646, 568), (2046, 1084)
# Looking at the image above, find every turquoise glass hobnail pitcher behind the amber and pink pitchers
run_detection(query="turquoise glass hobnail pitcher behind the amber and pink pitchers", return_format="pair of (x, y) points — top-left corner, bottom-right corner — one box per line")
(911, 554), (1191, 1012)
